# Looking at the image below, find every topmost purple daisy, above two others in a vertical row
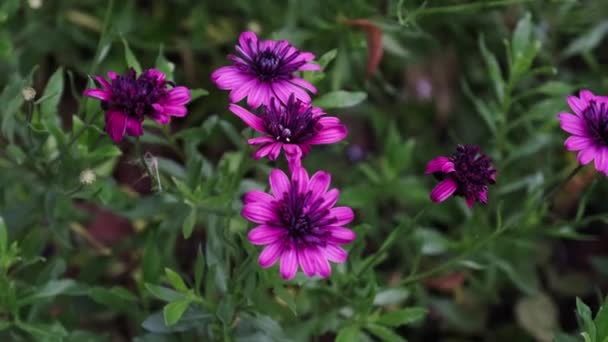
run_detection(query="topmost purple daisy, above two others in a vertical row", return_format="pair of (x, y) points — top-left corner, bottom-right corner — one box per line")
(211, 32), (320, 108)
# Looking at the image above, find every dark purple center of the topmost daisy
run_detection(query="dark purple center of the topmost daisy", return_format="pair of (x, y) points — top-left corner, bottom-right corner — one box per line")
(232, 40), (306, 82)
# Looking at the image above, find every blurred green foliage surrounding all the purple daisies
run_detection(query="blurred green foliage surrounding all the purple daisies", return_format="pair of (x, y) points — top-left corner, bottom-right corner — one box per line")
(0, 0), (608, 341)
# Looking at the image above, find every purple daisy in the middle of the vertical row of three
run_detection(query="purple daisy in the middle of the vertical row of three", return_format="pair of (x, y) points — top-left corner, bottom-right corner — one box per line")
(230, 96), (348, 169)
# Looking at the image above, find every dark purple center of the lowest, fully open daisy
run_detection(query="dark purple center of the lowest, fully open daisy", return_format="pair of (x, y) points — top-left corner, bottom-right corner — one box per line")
(279, 184), (335, 246)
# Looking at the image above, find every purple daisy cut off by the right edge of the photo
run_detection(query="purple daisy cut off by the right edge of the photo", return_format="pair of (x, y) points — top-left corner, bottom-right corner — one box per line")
(557, 90), (608, 175)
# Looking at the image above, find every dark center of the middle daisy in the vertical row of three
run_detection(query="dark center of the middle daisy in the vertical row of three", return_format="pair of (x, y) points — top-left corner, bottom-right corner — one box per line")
(262, 94), (319, 144)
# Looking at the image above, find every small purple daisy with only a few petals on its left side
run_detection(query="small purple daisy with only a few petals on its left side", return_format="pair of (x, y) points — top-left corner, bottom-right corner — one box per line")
(425, 145), (496, 208)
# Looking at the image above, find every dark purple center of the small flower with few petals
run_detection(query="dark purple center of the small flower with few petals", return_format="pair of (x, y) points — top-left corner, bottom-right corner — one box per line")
(449, 145), (496, 199)
